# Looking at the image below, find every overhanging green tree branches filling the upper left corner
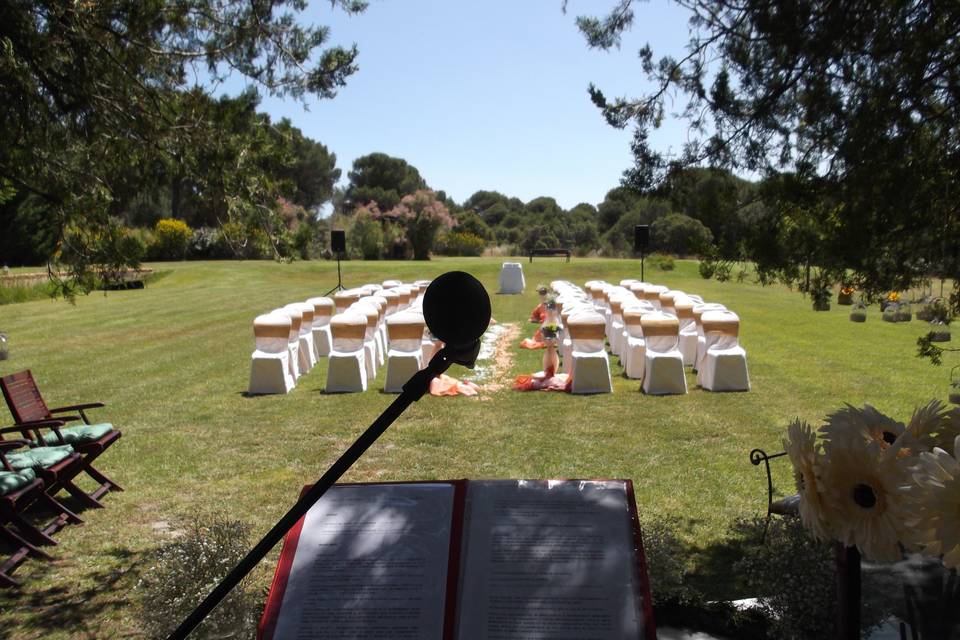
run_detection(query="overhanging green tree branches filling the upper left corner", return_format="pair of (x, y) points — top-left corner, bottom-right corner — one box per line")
(0, 0), (365, 288)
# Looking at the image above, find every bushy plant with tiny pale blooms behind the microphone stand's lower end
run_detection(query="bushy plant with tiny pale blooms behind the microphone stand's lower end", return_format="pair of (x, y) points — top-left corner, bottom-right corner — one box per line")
(136, 514), (260, 638)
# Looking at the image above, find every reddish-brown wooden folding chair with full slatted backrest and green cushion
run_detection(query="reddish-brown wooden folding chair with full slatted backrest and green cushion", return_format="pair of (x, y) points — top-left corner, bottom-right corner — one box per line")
(0, 370), (123, 507)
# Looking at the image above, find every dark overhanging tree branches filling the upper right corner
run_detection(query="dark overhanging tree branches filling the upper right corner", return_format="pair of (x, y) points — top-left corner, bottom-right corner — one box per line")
(578, 0), (960, 291)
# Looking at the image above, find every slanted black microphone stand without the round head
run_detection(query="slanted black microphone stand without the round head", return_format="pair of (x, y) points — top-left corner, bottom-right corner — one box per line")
(169, 340), (480, 640)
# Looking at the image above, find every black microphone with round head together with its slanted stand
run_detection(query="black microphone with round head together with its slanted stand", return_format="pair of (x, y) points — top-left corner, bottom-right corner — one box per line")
(168, 271), (490, 640)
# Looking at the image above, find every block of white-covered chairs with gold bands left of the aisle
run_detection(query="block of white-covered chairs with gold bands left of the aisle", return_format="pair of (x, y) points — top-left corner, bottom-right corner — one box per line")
(249, 280), (438, 394)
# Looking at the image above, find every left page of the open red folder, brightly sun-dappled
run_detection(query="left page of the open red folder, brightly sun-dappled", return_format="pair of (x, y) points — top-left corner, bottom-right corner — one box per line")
(273, 484), (454, 640)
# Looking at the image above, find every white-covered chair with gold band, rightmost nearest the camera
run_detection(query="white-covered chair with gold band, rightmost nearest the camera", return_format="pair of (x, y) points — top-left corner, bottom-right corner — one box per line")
(697, 310), (750, 391)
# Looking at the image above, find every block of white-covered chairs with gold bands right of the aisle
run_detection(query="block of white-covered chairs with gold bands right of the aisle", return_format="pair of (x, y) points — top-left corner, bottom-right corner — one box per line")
(551, 280), (750, 395)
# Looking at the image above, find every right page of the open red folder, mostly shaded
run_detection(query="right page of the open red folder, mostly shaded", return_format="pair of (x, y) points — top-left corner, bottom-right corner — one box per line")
(458, 480), (643, 640)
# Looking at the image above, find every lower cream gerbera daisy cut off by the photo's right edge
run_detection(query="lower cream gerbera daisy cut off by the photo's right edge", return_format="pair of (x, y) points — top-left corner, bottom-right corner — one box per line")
(910, 436), (960, 569)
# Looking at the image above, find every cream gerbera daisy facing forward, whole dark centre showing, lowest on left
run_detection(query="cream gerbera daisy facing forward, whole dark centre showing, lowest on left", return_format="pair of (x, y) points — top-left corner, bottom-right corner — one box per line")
(818, 437), (910, 562)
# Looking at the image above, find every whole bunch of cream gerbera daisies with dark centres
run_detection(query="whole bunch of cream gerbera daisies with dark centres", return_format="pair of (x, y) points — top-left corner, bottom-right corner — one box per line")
(783, 400), (960, 568)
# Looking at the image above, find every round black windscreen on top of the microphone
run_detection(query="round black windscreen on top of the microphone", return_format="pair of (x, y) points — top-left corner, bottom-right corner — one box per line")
(423, 271), (490, 347)
